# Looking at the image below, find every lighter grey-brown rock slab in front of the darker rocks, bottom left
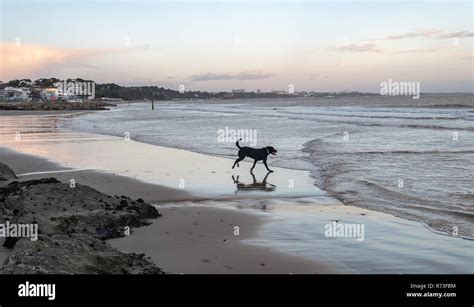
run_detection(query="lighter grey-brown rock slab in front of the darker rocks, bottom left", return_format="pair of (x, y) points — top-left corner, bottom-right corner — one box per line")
(0, 234), (162, 274)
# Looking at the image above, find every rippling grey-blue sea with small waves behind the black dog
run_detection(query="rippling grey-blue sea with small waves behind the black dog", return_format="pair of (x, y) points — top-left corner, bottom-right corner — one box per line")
(63, 94), (474, 238)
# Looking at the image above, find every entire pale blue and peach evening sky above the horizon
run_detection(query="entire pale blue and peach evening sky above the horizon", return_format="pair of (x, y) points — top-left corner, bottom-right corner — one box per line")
(0, 0), (474, 92)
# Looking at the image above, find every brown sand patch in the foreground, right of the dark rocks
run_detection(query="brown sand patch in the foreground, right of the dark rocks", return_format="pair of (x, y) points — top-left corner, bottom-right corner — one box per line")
(109, 206), (337, 274)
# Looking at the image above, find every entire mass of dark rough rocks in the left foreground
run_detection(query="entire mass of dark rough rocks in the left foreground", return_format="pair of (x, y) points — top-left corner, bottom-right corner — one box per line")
(0, 178), (162, 274)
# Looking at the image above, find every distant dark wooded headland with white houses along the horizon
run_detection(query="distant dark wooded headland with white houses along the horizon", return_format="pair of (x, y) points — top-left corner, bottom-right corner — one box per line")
(0, 78), (377, 102)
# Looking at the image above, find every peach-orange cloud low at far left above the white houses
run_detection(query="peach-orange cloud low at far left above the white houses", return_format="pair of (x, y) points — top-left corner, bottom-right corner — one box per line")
(0, 43), (141, 80)
